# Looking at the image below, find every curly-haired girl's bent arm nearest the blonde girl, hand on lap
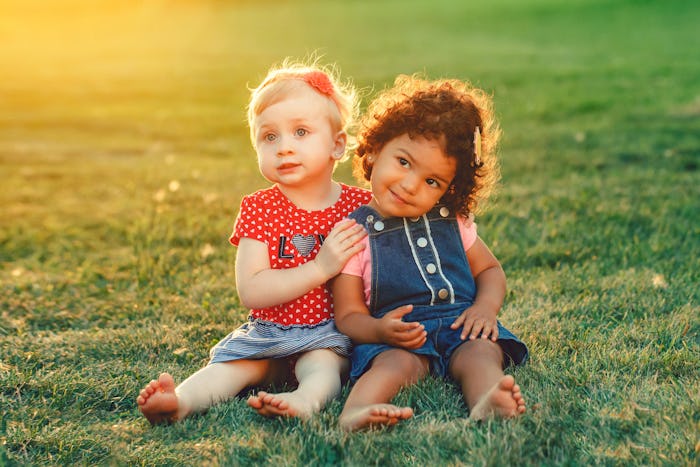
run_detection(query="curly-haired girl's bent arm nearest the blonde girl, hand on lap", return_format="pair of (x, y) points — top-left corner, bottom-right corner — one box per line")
(331, 274), (426, 349)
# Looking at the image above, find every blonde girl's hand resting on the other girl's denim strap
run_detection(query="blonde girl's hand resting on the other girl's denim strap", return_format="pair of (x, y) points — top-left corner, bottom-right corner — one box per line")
(314, 219), (367, 279)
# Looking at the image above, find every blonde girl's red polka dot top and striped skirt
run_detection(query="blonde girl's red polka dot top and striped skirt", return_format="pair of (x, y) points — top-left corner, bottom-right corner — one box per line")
(211, 184), (371, 363)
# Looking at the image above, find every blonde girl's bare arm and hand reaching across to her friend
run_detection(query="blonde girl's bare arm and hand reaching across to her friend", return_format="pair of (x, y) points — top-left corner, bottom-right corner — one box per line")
(236, 220), (366, 308)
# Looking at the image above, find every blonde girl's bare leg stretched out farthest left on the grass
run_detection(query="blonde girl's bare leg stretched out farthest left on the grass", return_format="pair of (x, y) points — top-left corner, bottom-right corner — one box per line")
(136, 360), (281, 425)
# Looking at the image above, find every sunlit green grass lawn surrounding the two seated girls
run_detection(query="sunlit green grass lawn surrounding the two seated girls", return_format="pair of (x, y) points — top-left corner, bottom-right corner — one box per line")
(0, 0), (700, 465)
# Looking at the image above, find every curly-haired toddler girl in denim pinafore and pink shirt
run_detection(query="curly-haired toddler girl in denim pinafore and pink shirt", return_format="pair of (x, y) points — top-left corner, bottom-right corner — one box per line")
(331, 76), (527, 430)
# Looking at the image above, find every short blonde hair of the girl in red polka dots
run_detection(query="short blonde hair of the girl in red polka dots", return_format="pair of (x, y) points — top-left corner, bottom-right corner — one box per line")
(247, 58), (359, 159)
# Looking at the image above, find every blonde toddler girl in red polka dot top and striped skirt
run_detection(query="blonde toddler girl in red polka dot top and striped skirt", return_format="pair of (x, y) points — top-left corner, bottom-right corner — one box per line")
(137, 62), (370, 424)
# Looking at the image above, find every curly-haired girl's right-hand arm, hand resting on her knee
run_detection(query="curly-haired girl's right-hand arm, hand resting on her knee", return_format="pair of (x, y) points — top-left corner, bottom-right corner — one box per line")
(451, 237), (506, 341)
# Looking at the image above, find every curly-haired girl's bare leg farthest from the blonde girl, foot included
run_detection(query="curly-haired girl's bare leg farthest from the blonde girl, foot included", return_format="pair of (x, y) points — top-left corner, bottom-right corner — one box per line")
(450, 339), (525, 420)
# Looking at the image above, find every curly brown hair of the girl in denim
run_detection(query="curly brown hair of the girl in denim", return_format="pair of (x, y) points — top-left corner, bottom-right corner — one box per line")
(353, 75), (501, 216)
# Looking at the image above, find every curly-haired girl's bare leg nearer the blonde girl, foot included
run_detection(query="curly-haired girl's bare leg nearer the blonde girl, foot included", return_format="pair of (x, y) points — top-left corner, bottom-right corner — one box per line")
(339, 349), (428, 431)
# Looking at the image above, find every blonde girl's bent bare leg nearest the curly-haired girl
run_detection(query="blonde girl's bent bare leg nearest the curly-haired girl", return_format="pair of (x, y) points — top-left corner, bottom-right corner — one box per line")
(248, 349), (348, 419)
